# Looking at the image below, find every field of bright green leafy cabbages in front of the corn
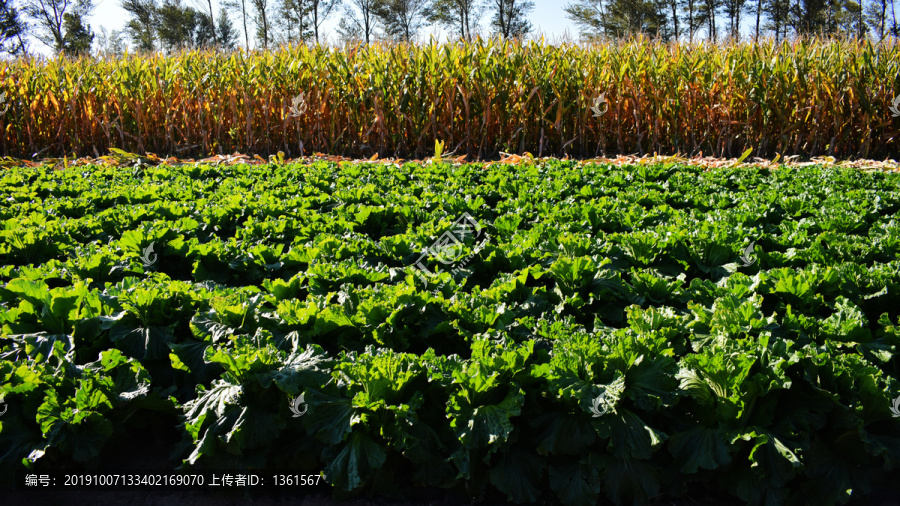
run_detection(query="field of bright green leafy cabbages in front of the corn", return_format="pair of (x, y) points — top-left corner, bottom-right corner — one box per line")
(0, 156), (900, 505)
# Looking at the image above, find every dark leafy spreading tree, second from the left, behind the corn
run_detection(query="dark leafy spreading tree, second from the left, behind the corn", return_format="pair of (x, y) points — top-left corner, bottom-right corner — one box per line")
(22, 0), (94, 53)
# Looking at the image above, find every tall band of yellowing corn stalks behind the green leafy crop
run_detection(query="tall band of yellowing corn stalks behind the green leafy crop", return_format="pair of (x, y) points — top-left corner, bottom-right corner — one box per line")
(0, 39), (900, 158)
